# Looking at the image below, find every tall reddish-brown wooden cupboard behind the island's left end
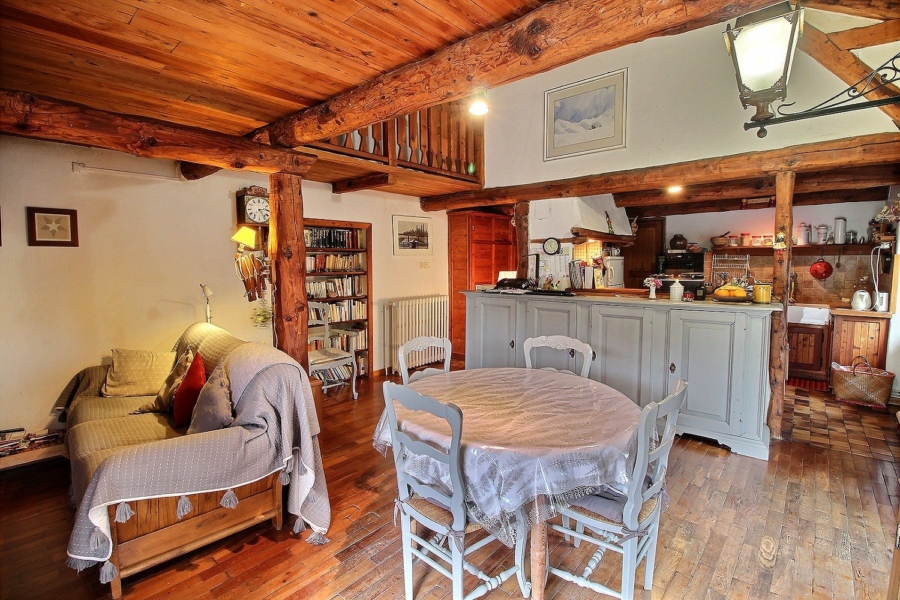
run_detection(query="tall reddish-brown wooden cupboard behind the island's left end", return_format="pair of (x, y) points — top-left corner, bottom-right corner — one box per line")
(447, 211), (518, 358)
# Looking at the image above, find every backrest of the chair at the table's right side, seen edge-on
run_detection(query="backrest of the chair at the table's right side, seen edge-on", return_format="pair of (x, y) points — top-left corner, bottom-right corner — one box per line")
(623, 379), (688, 528)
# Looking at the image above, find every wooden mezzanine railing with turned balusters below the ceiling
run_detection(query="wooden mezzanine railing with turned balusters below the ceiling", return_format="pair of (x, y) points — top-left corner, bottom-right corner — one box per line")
(310, 99), (484, 183)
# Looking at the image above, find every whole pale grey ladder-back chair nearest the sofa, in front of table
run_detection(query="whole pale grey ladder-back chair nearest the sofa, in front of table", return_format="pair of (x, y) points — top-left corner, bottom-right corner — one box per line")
(383, 381), (531, 600)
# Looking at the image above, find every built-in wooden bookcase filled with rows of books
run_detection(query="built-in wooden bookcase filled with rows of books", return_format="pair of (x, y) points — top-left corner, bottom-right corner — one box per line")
(303, 219), (373, 377)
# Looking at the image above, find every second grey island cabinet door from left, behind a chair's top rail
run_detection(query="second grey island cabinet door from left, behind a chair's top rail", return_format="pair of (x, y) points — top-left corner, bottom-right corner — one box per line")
(516, 300), (581, 373)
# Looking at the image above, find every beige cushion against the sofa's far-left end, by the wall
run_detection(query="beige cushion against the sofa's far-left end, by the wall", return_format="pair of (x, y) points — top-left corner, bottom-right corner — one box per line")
(100, 348), (175, 397)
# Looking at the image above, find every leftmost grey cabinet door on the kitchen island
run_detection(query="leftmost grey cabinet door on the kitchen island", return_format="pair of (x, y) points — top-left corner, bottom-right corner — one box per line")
(466, 296), (521, 369)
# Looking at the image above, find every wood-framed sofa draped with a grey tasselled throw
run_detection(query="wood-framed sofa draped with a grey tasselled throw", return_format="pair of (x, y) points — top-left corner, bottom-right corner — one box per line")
(61, 323), (331, 598)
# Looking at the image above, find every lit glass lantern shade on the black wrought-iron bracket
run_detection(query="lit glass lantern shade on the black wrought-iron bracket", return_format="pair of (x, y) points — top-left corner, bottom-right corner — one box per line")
(725, 2), (803, 121)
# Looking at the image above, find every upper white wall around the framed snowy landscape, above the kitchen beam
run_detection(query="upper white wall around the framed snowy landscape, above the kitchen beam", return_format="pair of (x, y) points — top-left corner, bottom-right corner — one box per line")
(485, 25), (896, 187)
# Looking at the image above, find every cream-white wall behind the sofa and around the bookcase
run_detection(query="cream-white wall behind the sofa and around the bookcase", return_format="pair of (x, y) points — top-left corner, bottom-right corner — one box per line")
(0, 136), (447, 430)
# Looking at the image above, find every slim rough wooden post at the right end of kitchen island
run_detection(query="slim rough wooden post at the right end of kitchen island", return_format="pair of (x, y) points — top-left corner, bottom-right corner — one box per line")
(768, 171), (796, 440)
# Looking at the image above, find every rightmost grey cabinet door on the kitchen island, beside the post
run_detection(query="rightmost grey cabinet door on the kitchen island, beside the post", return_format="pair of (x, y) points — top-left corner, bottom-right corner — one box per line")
(669, 310), (744, 435)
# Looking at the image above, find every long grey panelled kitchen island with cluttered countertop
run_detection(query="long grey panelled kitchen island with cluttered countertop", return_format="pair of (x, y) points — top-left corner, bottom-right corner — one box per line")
(463, 292), (781, 459)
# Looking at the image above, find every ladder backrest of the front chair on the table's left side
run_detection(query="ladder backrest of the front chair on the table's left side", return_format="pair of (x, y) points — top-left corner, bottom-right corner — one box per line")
(383, 381), (466, 531)
